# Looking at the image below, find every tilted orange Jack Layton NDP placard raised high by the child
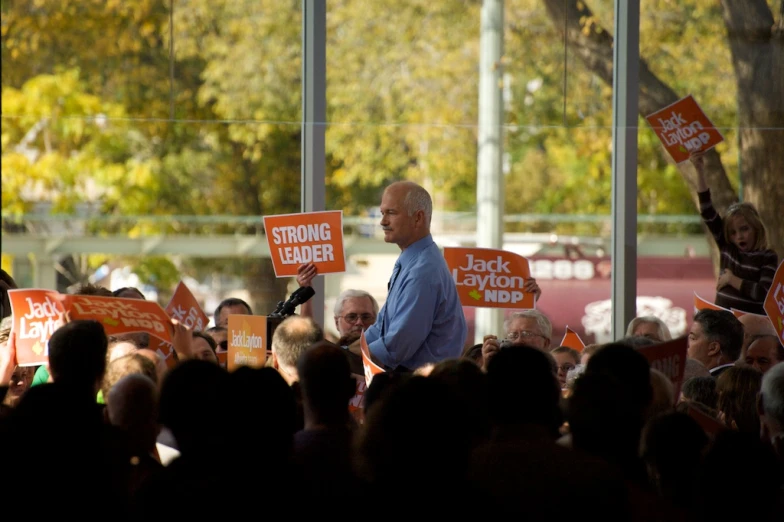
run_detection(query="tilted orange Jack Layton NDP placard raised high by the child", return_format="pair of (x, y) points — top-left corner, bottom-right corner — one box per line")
(645, 94), (724, 163)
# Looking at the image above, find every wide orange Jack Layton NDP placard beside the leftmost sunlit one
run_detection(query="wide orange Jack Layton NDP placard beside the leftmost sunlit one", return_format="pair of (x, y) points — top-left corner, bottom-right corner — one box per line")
(57, 292), (173, 343)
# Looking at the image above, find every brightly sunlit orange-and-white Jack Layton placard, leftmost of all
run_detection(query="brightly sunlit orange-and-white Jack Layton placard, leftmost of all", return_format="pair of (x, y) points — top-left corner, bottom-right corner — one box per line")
(8, 289), (65, 366)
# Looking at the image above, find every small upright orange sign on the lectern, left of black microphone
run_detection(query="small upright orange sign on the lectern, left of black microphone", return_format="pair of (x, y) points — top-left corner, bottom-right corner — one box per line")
(226, 315), (267, 372)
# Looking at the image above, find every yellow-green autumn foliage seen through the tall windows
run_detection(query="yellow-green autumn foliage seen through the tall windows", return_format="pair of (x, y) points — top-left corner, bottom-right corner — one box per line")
(0, 0), (764, 279)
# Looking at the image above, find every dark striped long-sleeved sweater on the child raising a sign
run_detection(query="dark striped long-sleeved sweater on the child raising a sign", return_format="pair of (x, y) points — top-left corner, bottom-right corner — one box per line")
(698, 190), (778, 315)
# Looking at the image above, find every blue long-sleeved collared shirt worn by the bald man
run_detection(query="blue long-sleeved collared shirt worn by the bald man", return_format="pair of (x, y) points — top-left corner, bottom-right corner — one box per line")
(365, 235), (468, 370)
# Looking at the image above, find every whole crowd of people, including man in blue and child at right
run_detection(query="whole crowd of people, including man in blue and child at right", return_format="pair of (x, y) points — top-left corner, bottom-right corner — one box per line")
(0, 176), (784, 522)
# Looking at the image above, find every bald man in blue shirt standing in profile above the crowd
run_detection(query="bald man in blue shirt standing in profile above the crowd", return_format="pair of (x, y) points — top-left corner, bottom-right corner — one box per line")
(365, 181), (468, 371)
